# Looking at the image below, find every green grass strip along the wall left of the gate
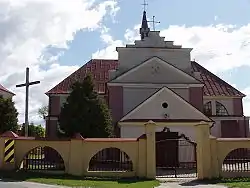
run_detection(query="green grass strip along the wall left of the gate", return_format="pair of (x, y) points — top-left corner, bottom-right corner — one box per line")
(0, 172), (159, 188)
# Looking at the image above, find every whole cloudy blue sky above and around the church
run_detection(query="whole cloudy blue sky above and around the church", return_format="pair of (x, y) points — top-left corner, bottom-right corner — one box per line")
(0, 0), (250, 123)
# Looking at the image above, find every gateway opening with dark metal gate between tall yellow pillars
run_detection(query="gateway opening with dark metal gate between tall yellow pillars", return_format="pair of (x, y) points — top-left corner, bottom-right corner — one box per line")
(155, 128), (197, 178)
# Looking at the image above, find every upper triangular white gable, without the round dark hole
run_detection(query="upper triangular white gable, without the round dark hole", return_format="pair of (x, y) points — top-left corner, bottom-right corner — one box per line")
(111, 57), (200, 84)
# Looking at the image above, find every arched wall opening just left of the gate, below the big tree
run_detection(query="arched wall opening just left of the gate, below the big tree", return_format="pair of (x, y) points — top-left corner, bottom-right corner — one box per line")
(88, 147), (133, 172)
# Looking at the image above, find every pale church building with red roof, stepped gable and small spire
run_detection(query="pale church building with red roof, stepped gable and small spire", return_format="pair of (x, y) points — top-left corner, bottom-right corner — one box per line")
(46, 11), (249, 141)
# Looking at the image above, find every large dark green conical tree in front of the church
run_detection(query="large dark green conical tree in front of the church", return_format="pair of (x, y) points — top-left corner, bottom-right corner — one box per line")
(59, 75), (113, 138)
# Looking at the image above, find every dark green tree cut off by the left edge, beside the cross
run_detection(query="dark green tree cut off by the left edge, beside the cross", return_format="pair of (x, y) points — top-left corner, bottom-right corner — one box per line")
(0, 95), (18, 134)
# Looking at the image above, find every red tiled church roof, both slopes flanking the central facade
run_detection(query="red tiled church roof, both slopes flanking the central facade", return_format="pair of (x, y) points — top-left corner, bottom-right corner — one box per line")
(46, 59), (245, 97)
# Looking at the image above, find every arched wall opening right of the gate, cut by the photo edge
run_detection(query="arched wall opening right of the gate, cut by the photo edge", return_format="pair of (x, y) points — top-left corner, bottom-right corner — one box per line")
(222, 148), (250, 176)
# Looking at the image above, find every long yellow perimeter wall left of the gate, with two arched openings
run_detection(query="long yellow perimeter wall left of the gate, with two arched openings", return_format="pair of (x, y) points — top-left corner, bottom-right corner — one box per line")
(0, 122), (155, 179)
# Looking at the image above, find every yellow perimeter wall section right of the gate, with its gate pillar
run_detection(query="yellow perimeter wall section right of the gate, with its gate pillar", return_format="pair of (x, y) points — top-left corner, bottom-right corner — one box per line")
(196, 123), (250, 179)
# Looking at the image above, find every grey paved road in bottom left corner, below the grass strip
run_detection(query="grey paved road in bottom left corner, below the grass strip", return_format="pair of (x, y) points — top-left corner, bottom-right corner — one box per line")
(0, 180), (66, 188)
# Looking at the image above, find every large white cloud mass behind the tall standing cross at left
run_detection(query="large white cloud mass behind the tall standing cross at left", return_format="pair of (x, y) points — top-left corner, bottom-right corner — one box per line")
(0, 0), (119, 123)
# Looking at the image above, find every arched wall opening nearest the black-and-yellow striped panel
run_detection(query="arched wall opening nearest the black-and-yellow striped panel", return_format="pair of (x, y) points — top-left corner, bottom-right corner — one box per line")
(20, 146), (65, 173)
